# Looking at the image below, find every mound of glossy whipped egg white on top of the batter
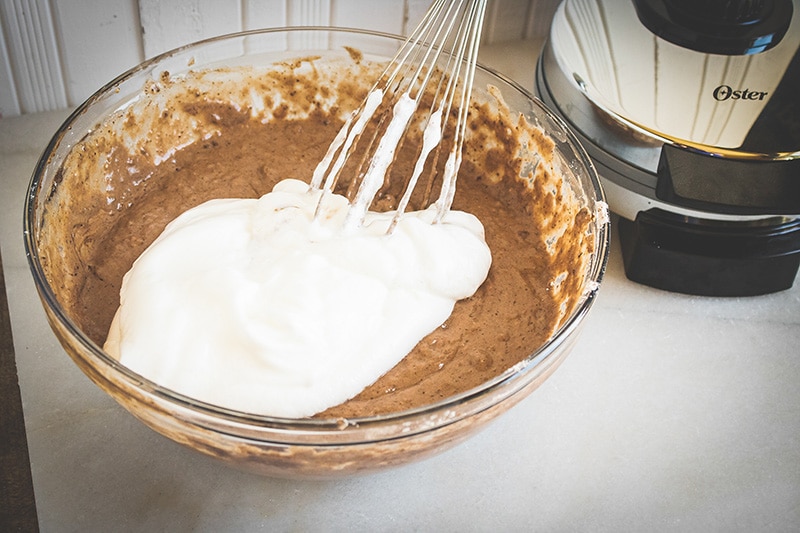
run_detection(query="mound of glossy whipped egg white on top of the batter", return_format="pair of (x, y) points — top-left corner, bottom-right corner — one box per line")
(104, 180), (491, 418)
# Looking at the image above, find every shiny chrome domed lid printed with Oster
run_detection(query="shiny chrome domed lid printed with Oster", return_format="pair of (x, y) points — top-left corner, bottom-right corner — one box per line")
(550, 0), (800, 158)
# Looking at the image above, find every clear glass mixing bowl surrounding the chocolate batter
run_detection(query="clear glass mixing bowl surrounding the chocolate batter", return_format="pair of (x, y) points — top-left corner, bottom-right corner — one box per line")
(24, 28), (609, 477)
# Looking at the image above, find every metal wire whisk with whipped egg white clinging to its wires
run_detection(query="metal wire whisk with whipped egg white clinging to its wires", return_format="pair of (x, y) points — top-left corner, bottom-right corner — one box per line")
(311, 0), (487, 232)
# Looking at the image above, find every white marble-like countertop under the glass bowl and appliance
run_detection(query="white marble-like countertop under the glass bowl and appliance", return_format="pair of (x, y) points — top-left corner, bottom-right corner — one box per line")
(0, 42), (800, 531)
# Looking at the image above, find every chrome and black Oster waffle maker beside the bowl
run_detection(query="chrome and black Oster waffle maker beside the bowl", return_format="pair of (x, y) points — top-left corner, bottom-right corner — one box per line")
(536, 0), (800, 296)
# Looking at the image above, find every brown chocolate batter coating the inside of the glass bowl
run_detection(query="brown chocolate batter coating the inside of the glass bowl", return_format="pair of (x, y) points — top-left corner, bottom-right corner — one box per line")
(42, 54), (593, 418)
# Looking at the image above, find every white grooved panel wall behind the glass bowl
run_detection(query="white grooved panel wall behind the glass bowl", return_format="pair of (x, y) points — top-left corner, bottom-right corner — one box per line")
(0, 0), (558, 117)
